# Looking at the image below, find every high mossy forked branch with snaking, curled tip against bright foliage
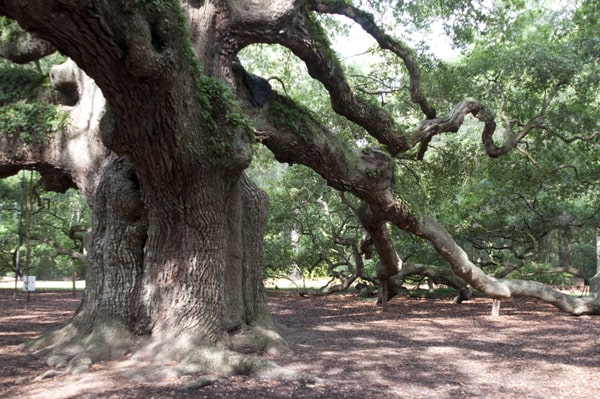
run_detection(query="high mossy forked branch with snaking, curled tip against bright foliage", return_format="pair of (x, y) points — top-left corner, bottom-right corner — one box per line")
(231, 5), (510, 156)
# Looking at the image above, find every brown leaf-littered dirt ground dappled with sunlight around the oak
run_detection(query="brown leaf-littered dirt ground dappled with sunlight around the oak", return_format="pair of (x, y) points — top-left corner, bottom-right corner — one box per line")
(0, 291), (600, 399)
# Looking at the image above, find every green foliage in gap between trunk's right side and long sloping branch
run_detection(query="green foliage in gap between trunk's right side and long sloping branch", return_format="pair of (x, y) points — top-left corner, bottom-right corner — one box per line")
(251, 148), (374, 277)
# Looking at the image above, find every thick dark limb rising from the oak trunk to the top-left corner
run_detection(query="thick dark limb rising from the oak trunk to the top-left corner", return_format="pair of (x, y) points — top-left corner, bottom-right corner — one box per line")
(0, 0), (187, 126)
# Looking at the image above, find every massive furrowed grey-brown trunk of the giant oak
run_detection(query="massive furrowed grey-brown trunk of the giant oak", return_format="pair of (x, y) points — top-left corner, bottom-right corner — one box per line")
(0, 1), (285, 370)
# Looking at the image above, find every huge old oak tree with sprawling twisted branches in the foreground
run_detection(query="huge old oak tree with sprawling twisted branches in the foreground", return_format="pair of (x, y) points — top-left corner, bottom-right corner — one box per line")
(0, 0), (600, 371)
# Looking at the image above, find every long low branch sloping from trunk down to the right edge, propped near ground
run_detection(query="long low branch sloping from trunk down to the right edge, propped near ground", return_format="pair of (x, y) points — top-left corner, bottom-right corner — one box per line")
(238, 78), (600, 315)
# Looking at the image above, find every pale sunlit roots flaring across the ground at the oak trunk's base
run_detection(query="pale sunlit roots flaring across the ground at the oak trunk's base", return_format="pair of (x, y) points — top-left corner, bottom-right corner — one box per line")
(25, 317), (319, 390)
